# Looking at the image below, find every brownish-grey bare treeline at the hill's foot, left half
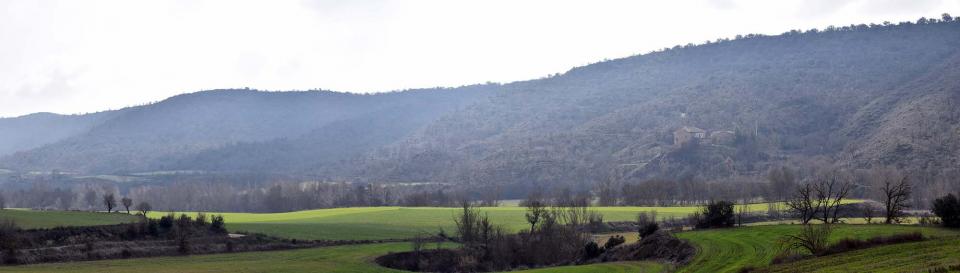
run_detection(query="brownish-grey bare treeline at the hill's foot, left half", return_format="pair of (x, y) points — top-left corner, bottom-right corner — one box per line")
(0, 178), (474, 212)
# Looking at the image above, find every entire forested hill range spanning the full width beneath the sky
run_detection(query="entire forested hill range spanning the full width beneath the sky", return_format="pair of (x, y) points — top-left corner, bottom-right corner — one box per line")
(0, 19), (960, 187)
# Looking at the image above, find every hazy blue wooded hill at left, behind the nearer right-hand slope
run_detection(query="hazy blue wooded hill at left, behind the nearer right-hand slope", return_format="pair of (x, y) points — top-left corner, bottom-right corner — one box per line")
(0, 86), (494, 173)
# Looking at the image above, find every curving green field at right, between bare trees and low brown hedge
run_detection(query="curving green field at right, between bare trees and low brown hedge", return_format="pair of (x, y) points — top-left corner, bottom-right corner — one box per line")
(677, 225), (960, 272)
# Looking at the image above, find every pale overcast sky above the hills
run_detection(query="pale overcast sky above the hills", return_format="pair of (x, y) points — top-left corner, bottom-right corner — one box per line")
(0, 0), (960, 117)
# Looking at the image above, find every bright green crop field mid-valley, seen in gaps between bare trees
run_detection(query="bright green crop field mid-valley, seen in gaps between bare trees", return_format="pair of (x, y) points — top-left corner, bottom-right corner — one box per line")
(150, 204), (788, 240)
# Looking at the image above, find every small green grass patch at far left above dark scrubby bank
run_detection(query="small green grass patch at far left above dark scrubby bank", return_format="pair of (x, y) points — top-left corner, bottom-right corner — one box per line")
(0, 209), (137, 228)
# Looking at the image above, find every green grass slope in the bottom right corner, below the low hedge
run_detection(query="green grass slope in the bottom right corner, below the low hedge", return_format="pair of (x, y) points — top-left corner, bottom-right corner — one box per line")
(761, 238), (960, 272)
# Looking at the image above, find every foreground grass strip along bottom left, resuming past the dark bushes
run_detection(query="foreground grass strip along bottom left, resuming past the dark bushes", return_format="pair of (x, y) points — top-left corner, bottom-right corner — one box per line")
(0, 243), (665, 273)
